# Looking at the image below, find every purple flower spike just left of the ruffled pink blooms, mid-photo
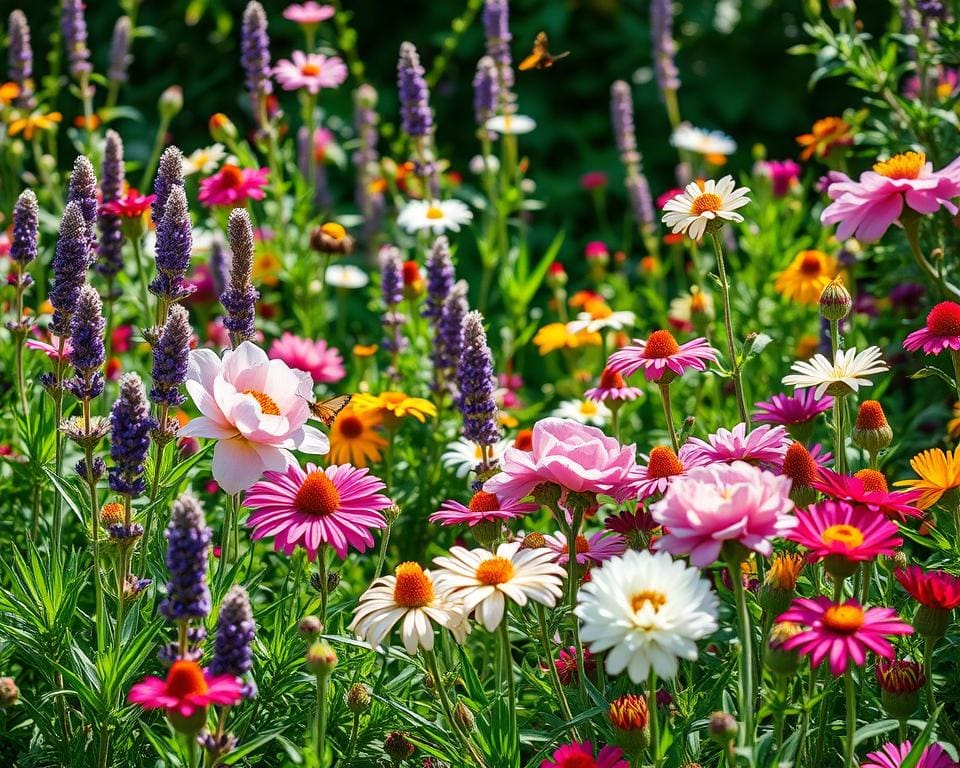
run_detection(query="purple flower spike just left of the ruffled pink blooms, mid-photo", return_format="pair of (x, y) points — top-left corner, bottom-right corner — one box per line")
(457, 311), (500, 445)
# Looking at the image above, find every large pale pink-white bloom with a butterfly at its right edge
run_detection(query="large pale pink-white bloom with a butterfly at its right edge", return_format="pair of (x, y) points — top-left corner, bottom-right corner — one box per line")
(179, 341), (330, 494)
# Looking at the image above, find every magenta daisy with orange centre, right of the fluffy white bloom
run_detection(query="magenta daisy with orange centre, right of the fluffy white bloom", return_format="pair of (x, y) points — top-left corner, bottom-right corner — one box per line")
(777, 596), (913, 675)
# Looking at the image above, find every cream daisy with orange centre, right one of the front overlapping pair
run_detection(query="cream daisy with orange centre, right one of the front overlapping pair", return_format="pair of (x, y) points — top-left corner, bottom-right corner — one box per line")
(434, 541), (564, 632)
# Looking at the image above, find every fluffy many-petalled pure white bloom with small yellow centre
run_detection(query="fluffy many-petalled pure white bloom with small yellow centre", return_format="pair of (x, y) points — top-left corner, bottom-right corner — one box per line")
(576, 551), (718, 684)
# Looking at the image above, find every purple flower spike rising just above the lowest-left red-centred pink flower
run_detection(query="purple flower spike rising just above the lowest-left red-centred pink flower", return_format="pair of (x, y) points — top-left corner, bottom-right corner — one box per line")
(159, 494), (212, 621)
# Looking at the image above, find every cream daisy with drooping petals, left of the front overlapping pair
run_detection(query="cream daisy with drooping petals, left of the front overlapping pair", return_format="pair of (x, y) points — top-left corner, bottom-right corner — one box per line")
(350, 563), (470, 655)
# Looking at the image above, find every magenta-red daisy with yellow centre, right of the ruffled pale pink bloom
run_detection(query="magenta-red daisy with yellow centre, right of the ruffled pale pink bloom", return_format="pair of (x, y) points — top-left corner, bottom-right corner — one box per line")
(787, 501), (903, 562)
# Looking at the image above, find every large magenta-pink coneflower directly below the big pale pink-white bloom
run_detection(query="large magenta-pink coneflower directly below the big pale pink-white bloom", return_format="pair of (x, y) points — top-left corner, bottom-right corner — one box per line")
(243, 463), (391, 560)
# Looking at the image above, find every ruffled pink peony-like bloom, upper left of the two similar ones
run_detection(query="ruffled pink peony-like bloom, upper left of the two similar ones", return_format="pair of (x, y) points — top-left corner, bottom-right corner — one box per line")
(483, 418), (637, 499)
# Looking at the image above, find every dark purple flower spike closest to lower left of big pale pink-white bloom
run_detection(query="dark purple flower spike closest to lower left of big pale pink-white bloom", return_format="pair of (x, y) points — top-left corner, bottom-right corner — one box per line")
(110, 374), (156, 496)
